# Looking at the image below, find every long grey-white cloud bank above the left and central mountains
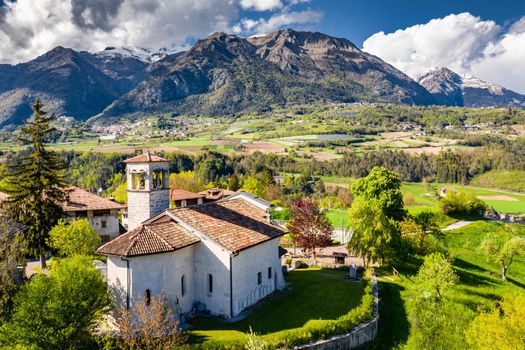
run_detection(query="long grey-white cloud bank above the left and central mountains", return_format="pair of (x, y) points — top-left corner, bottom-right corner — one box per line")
(0, 0), (322, 63)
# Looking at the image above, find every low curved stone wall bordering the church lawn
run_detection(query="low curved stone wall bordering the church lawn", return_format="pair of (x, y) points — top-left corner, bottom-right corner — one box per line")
(294, 274), (379, 350)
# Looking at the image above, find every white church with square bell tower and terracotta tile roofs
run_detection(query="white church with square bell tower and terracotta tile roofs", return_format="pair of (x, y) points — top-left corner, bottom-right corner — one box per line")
(97, 152), (285, 318)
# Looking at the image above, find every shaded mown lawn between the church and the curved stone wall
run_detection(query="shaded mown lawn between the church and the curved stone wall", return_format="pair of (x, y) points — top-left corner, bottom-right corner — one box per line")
(188, 268), (365, 347)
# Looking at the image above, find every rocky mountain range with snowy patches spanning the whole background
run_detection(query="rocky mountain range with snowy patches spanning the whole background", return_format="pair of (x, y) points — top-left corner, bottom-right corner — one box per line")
(0, 29), (524, 128)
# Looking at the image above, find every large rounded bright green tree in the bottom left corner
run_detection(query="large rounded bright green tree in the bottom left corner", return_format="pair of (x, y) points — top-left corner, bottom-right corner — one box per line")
(0, 256), (109, 350)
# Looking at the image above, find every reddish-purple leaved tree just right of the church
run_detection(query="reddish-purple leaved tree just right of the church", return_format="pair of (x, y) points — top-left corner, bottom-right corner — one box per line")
(286, 198), (334, 263)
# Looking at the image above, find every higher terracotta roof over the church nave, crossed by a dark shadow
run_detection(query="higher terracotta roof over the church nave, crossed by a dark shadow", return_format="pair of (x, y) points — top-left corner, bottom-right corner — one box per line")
(169, 198), (285, 252)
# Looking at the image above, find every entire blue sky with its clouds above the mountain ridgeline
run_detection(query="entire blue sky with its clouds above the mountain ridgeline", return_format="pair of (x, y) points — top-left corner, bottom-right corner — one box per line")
(0, 0), (525, 93)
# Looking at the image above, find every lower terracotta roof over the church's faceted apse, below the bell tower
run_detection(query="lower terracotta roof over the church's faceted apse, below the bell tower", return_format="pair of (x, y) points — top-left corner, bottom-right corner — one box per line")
(97, 221), (200, 257)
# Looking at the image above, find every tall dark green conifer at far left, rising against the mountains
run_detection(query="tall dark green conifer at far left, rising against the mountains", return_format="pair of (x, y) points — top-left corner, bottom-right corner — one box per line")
(5, 100), (68, 268)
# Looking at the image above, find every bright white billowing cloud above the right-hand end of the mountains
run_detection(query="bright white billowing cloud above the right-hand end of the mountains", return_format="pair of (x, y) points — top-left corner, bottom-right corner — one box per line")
(363, 13), (525, 93)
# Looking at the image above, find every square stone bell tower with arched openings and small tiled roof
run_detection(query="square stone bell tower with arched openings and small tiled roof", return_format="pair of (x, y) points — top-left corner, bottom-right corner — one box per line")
(124, 151), (170, 231)
